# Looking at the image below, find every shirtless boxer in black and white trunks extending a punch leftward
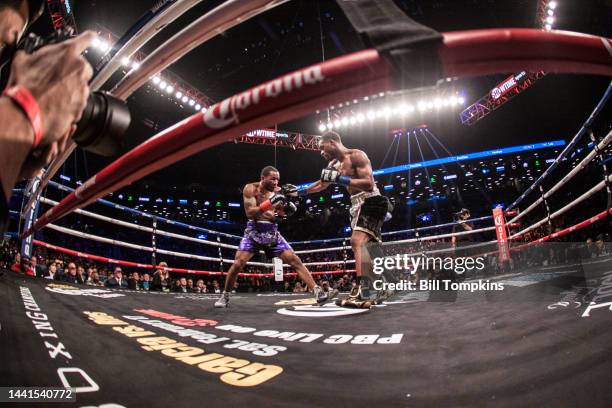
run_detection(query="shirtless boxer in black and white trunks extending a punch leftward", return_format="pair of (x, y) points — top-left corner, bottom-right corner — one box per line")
(287, 132), (392, 308)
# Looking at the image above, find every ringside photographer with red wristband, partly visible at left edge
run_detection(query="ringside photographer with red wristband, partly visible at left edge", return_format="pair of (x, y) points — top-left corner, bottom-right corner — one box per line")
(0, 0), (95, 231)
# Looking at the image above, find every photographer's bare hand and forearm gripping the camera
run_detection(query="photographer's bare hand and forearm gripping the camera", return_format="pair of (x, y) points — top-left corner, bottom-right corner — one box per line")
(0, 31), (96, 199)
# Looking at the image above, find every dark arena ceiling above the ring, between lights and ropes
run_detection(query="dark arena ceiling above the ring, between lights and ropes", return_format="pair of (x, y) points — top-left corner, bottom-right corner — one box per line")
(58, 0), (612, 191)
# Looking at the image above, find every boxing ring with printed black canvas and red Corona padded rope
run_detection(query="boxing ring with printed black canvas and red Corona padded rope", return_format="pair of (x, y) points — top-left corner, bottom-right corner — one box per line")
(0, 2), (612, 408)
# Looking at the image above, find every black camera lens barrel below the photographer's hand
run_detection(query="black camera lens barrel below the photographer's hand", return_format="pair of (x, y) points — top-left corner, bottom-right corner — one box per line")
(72, 91), (130, 156)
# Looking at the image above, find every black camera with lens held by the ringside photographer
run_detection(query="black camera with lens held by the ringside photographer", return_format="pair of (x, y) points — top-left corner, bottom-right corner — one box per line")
(0, 27), (131, 156)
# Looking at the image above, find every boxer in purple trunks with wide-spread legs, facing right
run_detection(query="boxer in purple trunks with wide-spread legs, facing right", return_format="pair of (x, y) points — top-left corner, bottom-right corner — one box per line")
(215, 166), (328, 307)
